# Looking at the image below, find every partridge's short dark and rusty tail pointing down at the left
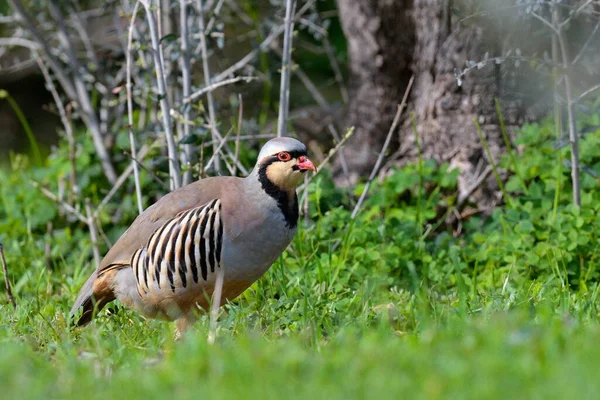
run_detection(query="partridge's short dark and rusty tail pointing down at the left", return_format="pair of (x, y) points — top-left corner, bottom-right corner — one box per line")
(70, 271), (115, 326)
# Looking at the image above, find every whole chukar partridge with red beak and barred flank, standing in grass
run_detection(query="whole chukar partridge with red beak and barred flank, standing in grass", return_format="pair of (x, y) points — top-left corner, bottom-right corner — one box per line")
(71, 138), (316, 333)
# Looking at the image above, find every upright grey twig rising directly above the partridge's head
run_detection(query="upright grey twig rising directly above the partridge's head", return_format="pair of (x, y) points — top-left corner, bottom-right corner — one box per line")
(277, 0), (296, 137)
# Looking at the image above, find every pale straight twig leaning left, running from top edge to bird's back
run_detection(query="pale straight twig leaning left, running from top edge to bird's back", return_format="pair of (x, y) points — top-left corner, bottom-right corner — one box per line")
(138, 0), (181, 190)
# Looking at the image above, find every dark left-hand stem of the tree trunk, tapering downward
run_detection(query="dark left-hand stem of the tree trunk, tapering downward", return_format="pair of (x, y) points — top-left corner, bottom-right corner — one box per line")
(338, 0), (414, 180)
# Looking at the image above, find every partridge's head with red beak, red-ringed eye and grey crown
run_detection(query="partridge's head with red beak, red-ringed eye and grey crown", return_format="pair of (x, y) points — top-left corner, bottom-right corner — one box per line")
(256, 137), (317, 191)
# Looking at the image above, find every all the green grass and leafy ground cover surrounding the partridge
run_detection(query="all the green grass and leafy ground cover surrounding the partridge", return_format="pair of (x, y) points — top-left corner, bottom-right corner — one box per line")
(0, 108), (600, 399)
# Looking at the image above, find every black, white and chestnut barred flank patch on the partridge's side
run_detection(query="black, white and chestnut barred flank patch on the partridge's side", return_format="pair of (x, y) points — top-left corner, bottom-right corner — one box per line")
(131, 200), (223, 297)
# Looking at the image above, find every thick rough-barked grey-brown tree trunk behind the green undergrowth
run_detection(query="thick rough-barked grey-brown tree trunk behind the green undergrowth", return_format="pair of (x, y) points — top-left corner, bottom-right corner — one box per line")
(338, 0), (540, 207)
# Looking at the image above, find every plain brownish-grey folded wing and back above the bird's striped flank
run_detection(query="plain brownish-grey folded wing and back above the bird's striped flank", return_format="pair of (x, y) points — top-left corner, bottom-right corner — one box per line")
(98, 177), (241, 275)
